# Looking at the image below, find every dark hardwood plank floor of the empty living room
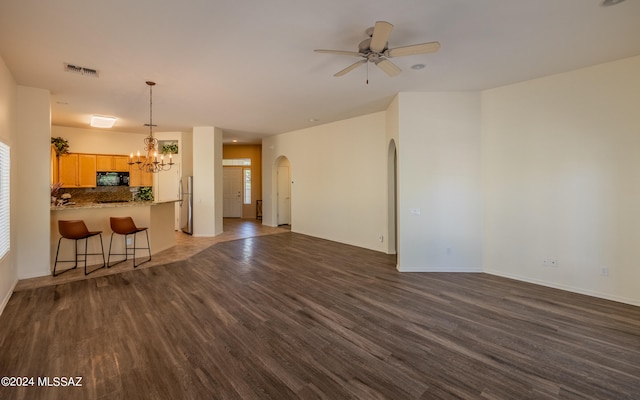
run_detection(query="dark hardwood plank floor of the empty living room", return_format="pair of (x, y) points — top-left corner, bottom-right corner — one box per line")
(0, 232), (640, 400)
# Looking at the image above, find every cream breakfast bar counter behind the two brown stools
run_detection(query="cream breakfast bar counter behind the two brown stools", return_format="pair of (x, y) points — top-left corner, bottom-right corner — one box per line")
(50, 201), (175, 271)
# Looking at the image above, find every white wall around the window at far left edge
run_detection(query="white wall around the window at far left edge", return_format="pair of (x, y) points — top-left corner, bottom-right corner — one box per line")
(0, 58), (18, 313)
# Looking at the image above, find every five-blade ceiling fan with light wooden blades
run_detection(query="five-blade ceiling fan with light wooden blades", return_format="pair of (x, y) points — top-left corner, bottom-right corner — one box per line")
(314, 21), (440, 79)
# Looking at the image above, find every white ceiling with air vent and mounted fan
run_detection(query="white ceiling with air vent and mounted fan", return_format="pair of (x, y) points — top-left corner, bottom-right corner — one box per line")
(0, 0), (640, 143)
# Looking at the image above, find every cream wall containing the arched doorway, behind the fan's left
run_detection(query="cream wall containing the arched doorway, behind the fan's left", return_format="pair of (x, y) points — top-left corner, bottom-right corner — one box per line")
(262, 112), (387, 251)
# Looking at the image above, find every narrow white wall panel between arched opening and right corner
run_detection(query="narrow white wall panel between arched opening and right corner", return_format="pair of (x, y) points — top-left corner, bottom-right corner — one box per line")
(397, 93), (482, 271)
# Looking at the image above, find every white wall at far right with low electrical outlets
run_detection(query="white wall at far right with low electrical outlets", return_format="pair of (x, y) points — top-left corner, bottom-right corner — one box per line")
(482, 57), (640, 304)
